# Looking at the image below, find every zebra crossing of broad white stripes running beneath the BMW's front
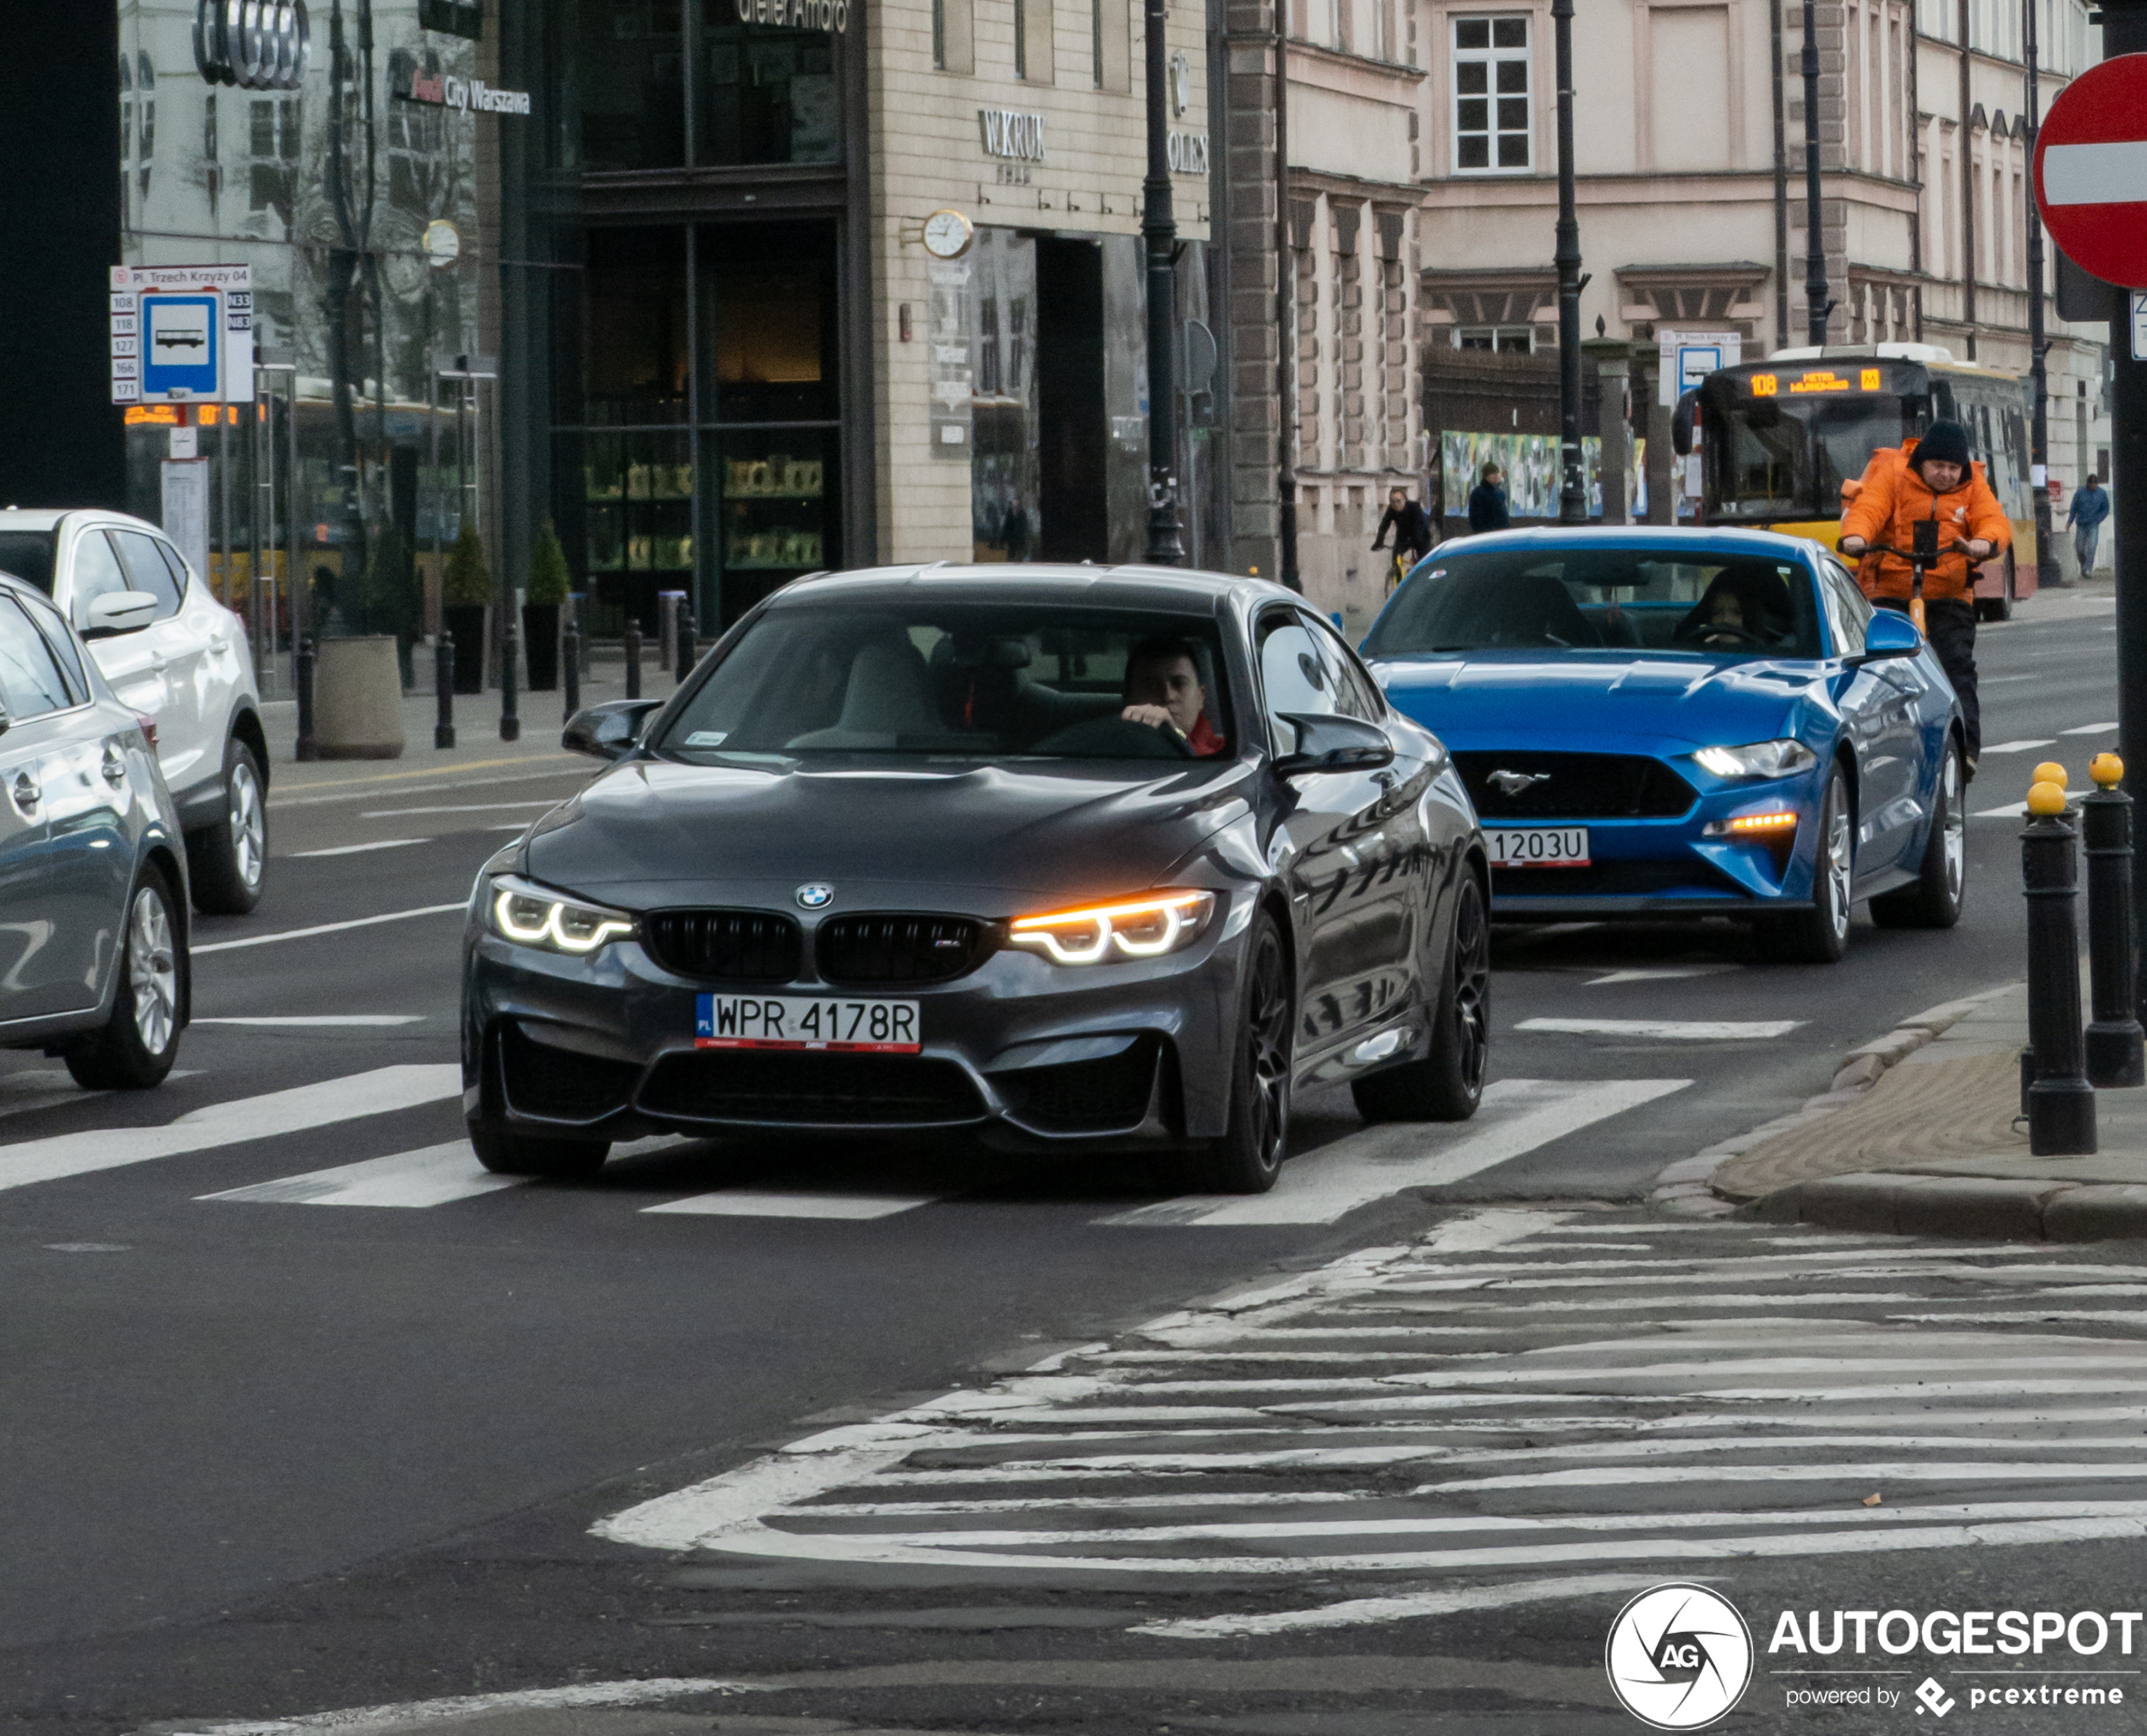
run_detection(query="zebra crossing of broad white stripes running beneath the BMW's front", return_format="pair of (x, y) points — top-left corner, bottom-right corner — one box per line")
(0, 1064), (1690, 1230)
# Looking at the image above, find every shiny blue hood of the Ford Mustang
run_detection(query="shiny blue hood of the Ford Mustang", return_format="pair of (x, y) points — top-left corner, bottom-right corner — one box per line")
(1374, 652), (1816, 747)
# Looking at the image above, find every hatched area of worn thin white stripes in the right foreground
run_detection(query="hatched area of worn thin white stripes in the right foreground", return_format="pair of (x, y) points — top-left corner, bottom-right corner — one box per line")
(593, 1206), (2147, 1640)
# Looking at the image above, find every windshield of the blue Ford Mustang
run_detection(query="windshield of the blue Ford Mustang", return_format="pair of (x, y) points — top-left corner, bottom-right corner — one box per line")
(1363, 545), (1821, 657)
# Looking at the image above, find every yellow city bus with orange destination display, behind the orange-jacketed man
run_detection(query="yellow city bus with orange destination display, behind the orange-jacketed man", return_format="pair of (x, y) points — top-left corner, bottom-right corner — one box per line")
(1698, 343), (2035, 620)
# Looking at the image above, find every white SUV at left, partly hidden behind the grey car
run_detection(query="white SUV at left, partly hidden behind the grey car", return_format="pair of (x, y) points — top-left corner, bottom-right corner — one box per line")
(0, 506), (269, 916)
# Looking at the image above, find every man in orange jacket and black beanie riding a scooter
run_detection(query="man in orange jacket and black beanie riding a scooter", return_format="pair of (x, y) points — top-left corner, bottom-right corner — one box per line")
(1840, 423), (2012, 777)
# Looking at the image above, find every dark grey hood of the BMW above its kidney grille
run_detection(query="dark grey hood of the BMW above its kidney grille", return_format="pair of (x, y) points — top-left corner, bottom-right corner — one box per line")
(524, 760), (1249, 914)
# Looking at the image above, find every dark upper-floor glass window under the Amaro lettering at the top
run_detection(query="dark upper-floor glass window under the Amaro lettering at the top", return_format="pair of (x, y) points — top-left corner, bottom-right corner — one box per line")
(693, 0), (841, 165)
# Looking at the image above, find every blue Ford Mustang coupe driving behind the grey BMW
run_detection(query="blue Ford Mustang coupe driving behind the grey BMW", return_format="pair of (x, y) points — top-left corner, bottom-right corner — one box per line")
(1363, 526), (1967, 961)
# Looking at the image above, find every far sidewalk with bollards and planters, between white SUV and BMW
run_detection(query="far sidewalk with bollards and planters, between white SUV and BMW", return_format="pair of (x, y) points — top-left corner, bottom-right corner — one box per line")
(262, 648), (675, 809)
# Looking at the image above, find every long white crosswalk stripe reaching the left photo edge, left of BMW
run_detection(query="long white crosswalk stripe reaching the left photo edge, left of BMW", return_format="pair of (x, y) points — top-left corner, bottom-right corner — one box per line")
(0, 1064), (462, 1191)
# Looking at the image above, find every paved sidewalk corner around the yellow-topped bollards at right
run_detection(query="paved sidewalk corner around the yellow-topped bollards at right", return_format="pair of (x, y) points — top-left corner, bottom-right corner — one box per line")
(1664, 983), (2147, 1242)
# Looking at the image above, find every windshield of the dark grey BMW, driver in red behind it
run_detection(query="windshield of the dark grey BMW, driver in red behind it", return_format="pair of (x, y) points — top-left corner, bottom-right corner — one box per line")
(655, 598), (1230, 760)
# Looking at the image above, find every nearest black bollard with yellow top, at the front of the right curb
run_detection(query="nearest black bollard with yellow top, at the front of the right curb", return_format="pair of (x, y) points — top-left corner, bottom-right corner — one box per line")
(2020, 783), (2095, 1156)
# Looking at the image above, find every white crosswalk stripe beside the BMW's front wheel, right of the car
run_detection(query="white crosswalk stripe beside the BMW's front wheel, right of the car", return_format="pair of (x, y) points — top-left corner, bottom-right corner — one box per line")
(1097, 1079), (1692, 1230)
